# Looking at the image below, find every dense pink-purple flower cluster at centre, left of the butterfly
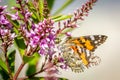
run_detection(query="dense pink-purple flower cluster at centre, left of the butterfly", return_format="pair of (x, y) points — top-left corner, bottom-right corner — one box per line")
(26, 18), (56, 57)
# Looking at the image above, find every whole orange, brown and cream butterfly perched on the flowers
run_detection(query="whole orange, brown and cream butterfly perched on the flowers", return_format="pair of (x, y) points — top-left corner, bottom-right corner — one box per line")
(63, 35), (107, 72)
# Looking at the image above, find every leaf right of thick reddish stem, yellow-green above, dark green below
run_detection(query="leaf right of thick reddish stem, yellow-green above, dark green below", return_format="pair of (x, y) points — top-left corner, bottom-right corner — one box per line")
(26, 53), (40, 75)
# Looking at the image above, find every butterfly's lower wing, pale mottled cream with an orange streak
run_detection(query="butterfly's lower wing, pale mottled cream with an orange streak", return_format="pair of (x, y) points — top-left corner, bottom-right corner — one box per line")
(63, 47), (100, 72)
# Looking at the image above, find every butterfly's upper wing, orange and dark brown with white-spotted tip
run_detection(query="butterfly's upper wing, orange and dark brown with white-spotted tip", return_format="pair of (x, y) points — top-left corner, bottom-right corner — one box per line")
(66, 35), (107, 52)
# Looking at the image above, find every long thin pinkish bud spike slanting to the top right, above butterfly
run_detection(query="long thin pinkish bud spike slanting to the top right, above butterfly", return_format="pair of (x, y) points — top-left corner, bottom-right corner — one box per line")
(57, 0), (97, 35)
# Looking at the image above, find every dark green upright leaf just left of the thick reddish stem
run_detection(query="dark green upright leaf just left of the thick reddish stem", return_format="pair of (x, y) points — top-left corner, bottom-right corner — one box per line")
(7, 49), (16, 74)
